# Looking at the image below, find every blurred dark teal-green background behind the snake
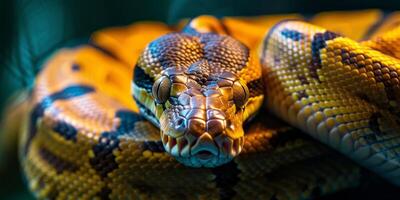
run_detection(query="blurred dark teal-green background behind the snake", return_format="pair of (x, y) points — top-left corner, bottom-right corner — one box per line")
(0, 0), (400, 199)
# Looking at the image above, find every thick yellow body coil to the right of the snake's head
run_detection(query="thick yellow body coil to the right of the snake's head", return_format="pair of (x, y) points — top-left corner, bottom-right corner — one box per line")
(262, 22), (400, 185)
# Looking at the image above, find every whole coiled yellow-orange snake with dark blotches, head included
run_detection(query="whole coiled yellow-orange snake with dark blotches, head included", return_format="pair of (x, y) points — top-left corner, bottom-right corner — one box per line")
(16, 10), (400, 200)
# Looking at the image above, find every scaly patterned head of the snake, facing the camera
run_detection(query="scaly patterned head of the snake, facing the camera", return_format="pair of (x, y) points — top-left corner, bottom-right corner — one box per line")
(133, 24), (262, 167)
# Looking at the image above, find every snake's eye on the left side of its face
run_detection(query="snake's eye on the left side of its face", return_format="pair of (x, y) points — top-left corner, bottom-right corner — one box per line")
(152, 76), (171, 103)
